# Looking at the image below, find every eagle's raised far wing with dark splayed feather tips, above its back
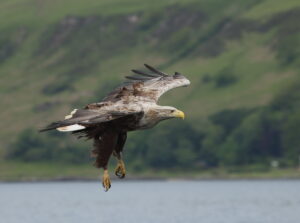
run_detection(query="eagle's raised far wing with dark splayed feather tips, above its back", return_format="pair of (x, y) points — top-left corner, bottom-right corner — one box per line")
(104, 64), (190, 102)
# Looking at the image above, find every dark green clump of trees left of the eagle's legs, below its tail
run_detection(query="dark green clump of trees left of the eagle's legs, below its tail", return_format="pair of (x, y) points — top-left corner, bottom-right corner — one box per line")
(6, 129), (89, 164)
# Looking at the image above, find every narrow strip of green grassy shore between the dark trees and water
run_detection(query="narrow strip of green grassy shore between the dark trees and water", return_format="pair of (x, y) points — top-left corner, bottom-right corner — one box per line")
(0, 162), (300, 183)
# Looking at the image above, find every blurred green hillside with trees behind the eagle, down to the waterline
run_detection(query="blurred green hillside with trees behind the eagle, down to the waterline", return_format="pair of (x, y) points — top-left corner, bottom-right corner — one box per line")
(0, 0), (300, 180)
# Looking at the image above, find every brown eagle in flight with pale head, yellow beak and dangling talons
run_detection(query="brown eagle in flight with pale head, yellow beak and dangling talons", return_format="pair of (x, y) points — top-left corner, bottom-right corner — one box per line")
(41, 64), (190, 191)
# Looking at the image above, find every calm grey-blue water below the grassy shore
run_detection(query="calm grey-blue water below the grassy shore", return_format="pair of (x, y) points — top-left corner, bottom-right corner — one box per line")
(0, 181), (300, 223)
